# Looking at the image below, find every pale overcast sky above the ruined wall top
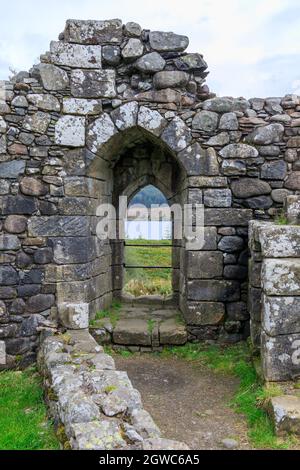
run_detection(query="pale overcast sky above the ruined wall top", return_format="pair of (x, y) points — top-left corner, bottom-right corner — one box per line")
(0, 0), (300, 98)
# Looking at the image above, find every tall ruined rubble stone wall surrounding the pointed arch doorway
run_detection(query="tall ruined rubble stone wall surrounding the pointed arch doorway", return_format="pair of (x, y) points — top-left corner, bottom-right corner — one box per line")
(0, 20), (300, 367)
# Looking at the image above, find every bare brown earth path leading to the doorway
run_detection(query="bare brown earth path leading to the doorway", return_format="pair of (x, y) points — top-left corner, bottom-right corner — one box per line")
(115, 354), (251, 450)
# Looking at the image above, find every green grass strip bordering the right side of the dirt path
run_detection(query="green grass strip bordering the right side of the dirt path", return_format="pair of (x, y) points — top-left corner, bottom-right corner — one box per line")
(157, 343), (295, 449)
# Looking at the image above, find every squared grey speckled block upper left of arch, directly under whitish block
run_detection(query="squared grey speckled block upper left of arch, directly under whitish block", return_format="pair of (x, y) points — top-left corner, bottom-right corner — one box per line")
(71, 70), (117, 98)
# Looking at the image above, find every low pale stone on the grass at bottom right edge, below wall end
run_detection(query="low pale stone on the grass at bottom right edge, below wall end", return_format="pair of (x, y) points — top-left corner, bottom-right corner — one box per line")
(270, 395), (300, 436)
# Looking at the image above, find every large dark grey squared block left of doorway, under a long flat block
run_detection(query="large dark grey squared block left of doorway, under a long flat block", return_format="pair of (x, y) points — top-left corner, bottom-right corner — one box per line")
(50, 236), (96, 264)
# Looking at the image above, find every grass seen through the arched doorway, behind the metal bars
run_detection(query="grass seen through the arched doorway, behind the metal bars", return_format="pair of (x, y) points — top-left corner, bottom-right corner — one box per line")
(124, 240), (172, 297)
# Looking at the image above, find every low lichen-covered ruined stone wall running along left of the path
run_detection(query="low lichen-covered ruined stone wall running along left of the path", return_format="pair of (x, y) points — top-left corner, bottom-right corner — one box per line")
(38, 330), (188, 450)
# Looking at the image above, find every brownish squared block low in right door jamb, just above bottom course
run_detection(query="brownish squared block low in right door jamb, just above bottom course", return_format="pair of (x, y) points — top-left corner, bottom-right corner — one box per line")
(184, 302), (225, 326)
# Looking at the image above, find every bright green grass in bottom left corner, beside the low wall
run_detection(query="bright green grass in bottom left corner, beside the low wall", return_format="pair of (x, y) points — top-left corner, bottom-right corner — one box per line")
(0, 368), (60, 450)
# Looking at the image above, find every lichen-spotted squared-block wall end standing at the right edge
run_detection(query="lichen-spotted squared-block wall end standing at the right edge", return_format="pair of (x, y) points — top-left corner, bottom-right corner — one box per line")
(249, 197), (300, 381)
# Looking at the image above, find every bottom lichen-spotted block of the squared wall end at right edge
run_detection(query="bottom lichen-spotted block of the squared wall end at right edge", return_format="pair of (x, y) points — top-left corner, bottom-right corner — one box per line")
(261, 331), (300, 382)
